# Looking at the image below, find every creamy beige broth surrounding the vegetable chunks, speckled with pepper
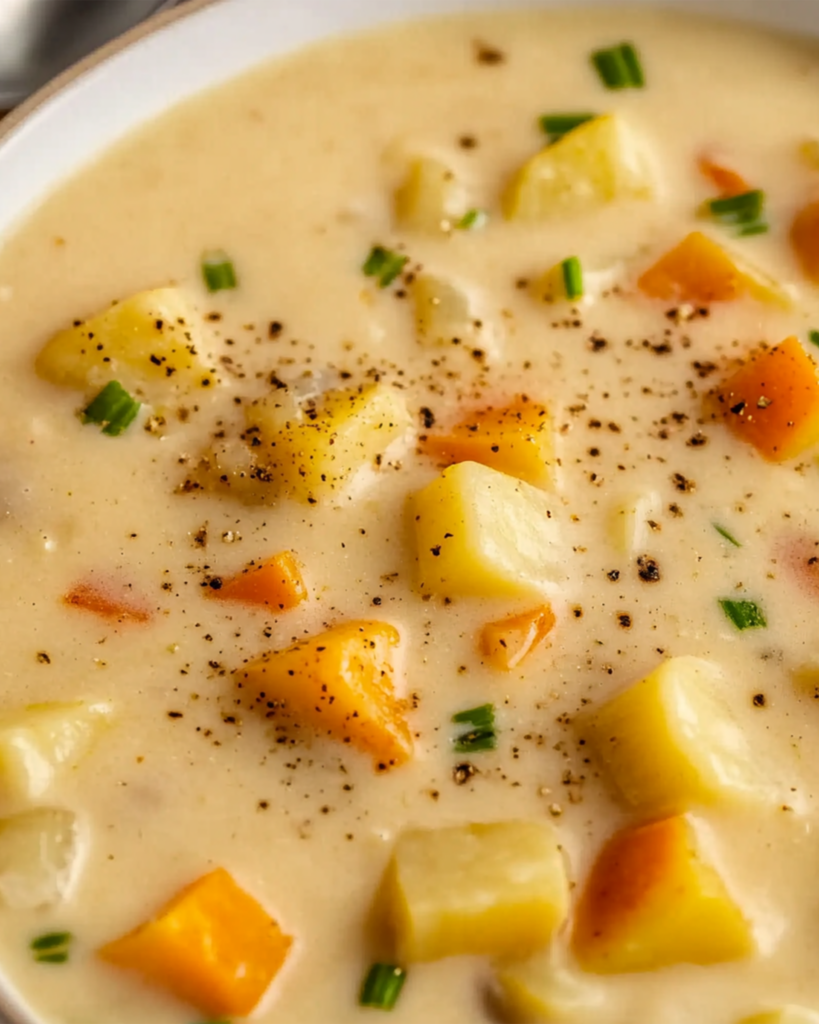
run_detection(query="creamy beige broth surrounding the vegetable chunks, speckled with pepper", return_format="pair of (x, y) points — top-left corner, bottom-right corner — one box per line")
(0, 12), (819, 1024)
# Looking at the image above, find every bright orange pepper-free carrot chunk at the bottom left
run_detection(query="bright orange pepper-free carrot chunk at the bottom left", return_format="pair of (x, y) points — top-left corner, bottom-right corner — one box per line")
(98, 867), (293, 1017)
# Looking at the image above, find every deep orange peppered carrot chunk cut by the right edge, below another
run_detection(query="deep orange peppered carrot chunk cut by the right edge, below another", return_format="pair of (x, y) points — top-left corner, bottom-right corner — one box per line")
(717, 338), (819, 462)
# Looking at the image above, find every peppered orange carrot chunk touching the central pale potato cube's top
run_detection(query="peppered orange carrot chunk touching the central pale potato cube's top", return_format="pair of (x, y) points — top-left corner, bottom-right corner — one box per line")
(421, 395), (552, 486)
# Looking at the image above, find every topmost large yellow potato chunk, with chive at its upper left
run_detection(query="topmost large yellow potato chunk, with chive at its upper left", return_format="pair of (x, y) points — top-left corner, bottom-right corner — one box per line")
(504, 115), (654, 220)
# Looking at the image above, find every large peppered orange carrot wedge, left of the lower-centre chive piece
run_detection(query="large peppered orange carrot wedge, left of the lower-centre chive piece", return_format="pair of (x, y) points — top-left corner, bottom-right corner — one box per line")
(236, 621), (413, 769)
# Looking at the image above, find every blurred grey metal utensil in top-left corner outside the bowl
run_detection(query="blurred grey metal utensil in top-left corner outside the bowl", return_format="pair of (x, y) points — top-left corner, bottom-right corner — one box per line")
(0, 0), (177, 110)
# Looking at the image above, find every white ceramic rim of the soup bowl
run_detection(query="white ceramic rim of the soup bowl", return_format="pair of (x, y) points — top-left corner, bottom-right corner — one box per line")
(0, 0), (819, 1024)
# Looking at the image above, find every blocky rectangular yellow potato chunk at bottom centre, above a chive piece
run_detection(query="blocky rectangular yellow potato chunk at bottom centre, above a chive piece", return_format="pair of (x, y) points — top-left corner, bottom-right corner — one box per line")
(383, 821), (569, 963)
